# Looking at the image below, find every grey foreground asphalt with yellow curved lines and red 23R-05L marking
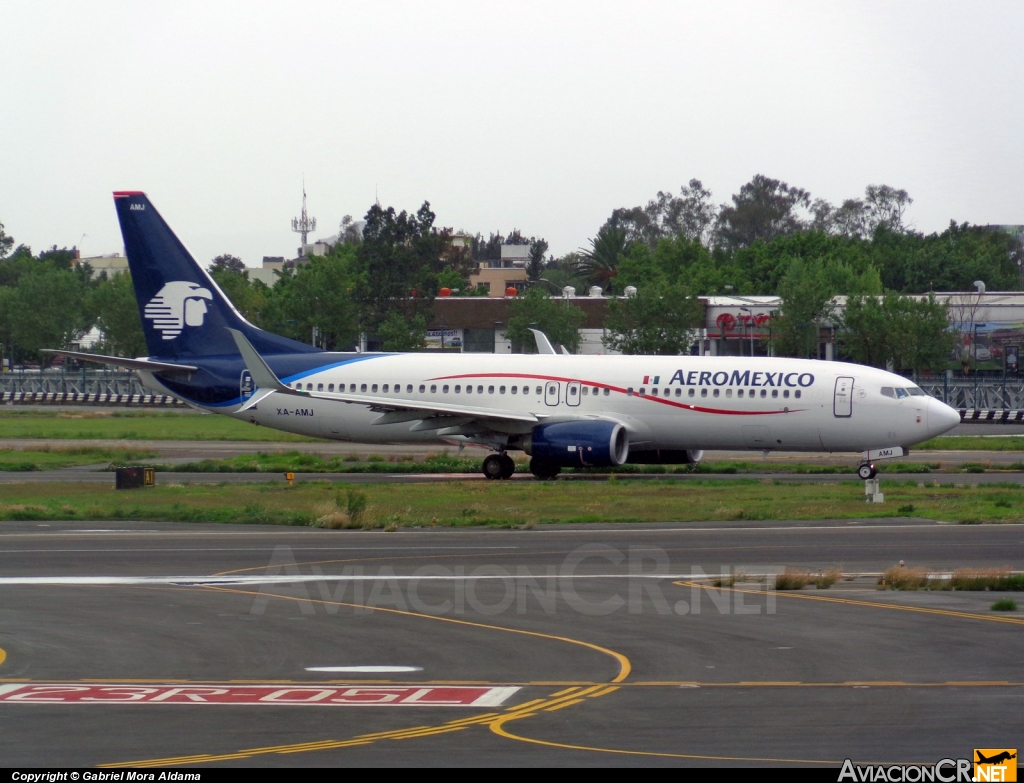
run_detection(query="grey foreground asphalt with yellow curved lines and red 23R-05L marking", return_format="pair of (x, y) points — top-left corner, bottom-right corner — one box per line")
(0, 519), (1024, 771)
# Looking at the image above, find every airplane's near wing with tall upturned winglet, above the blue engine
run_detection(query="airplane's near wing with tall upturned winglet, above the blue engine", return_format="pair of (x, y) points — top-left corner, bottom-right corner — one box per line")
(227, 329), (542, 429)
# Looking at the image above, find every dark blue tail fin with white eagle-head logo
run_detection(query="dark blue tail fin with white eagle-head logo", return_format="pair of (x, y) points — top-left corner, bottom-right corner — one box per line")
(114, 190), (317, 358)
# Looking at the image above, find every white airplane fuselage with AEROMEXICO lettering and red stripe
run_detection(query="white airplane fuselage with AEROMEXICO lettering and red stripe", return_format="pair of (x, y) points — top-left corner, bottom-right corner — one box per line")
(138, 353), (958, 451)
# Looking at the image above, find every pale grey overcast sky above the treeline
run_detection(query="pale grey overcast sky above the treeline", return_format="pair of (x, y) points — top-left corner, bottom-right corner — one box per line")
(0, 0), (1024, 266)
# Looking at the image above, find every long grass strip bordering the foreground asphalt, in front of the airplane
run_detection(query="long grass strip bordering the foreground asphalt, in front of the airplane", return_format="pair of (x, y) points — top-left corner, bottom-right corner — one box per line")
(0, 477), (1024, 528)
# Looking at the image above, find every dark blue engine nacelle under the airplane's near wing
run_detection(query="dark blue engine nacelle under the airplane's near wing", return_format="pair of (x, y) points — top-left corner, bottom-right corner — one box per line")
(523, 420), (630, 468)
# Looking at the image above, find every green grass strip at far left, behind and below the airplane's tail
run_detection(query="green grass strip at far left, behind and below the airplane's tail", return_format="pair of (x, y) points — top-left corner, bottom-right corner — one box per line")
(0, 408), (317, 443)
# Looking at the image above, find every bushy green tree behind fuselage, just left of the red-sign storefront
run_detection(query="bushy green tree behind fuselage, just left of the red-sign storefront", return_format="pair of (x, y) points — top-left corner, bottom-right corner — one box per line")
(604, 284), (703, 356)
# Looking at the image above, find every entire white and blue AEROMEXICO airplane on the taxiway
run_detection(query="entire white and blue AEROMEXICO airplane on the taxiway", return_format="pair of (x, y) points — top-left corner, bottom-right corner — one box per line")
(46, 190), (959, 479)
